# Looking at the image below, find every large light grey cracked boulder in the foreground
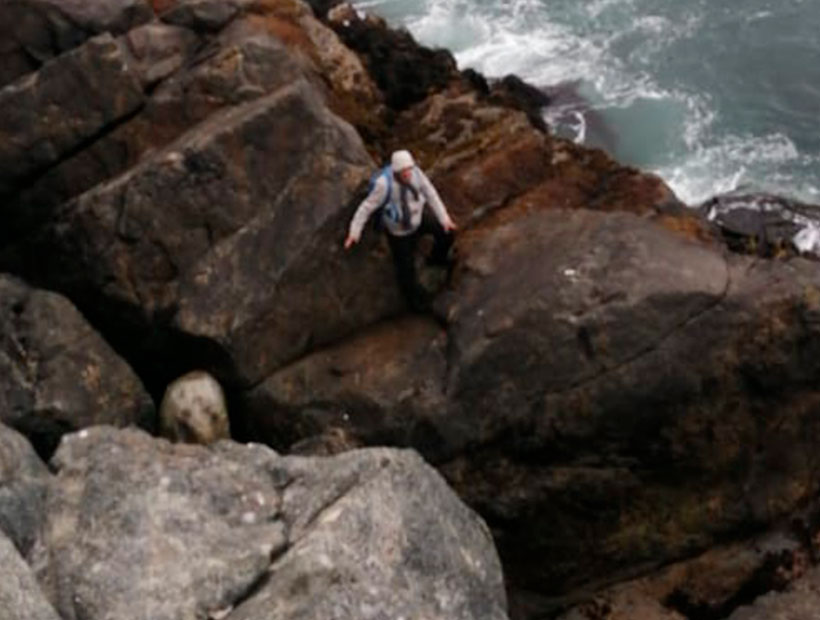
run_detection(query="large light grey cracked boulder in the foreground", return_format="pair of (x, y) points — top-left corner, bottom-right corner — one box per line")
(33, 427), (506, 620)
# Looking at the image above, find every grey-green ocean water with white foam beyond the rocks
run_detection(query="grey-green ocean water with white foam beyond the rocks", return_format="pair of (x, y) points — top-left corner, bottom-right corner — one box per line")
(355, 0), (820, 205)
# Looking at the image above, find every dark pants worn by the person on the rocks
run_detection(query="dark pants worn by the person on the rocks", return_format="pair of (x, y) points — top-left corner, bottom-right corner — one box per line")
(387, 211), (453, 312)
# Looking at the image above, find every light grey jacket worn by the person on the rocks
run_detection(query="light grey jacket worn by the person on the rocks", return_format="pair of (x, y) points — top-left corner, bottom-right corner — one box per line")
(349, 167), (450, 241)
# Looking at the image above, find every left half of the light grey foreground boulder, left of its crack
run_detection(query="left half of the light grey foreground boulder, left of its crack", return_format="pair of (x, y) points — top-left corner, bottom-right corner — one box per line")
(33, 427), (286, 620)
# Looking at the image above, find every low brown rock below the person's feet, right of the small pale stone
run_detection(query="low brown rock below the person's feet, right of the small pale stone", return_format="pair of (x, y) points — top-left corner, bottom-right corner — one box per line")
(243, 317), (456, 458)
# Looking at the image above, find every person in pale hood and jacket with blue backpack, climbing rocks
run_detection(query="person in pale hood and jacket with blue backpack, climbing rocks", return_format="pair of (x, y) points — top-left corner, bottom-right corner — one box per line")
(344, 151), (456, 312)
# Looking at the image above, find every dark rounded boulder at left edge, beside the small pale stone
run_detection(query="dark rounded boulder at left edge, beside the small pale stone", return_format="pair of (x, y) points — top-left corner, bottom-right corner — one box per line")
(0, 275), (154, 454)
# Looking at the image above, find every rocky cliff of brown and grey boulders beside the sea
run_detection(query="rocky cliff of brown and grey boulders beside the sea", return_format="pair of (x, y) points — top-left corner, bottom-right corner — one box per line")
(0, 0), (820, 620)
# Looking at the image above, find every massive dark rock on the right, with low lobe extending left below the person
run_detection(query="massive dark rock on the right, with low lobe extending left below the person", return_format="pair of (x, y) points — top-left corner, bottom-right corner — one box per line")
(245, 210), (820, 615)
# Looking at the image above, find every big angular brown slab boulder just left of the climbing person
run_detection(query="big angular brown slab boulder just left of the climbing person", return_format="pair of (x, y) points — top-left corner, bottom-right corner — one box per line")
(6, 76), (401, 385)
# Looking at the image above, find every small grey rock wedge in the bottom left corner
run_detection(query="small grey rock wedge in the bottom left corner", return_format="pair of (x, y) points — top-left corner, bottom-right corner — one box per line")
(0, 531), (60, 620)
